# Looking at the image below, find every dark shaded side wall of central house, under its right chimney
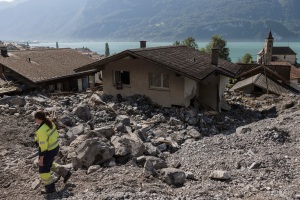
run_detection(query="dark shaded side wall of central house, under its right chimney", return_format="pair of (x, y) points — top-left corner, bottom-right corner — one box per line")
(198, 73), (220, 111)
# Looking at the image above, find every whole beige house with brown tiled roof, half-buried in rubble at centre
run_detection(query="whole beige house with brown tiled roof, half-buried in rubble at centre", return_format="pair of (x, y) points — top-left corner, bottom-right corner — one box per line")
(75, 41), (238, 111)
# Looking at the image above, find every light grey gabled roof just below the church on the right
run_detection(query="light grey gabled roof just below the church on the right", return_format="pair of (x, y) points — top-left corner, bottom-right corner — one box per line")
(230, 74), (289, 95)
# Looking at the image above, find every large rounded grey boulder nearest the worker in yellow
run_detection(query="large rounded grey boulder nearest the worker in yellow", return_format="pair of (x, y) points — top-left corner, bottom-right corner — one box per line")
(76, 137), (115, 167)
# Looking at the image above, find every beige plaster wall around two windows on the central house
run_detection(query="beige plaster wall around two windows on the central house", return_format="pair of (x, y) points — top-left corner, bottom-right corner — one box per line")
(103, 58), (185, 107)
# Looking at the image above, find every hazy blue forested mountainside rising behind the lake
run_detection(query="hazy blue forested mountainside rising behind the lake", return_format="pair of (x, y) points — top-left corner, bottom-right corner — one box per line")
(0, 0), (300, 41)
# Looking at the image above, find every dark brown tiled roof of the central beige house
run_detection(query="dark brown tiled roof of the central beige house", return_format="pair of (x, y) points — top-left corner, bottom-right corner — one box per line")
(75, 46), (239, 80)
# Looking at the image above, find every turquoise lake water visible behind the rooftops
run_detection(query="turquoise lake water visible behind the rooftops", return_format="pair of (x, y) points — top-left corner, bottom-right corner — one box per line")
(30, 41), (300, 62)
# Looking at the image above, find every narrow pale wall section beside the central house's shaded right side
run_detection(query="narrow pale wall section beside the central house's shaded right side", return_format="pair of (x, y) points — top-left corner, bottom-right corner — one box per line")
(183, 77), (198, 107)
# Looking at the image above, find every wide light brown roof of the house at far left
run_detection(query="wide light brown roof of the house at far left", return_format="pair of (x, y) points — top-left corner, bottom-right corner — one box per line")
(0, 49), (95, 83)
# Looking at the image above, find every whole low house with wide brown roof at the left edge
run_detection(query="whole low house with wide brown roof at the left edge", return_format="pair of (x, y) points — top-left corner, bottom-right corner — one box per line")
(0, 45), (95, 91)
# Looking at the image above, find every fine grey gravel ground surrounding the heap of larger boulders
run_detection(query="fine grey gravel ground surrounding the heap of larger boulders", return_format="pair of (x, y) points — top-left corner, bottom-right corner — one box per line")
(0, 92), (300, 200)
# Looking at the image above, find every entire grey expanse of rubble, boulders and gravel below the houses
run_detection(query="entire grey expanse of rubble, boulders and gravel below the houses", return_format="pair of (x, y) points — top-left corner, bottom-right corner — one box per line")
(0, 92), (300, 199)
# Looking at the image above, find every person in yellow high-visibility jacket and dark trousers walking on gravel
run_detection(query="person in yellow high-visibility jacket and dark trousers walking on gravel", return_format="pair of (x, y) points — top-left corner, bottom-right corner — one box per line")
(34, 111), (72, 193)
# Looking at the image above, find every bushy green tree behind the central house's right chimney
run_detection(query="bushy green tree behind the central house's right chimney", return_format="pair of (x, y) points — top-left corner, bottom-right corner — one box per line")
(200, 35), (231, 61)
